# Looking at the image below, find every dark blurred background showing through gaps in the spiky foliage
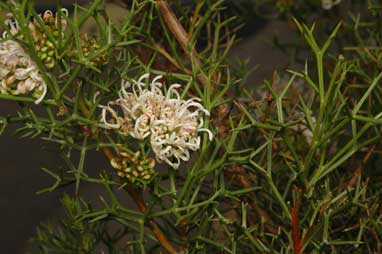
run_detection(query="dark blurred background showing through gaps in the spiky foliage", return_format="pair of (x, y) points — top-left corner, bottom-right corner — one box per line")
(0, 0), (293, 254)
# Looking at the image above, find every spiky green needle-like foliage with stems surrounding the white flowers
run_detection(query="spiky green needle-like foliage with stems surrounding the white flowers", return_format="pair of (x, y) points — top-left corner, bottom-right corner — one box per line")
(0, 0), (382, 254)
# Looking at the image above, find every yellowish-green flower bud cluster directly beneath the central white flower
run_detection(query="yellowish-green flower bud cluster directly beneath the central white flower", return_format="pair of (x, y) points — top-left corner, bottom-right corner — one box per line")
(110, 151), (155, 183)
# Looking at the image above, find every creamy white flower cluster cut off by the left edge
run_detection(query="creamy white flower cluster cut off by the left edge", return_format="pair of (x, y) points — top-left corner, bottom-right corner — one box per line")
(0, 17), (47, 104)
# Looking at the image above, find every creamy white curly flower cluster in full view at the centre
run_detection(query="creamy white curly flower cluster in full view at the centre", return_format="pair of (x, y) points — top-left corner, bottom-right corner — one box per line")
(101, 74), (212, 168)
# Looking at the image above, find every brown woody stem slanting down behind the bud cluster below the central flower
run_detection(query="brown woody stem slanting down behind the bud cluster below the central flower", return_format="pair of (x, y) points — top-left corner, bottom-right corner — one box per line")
(102, 147), (178, 254)
